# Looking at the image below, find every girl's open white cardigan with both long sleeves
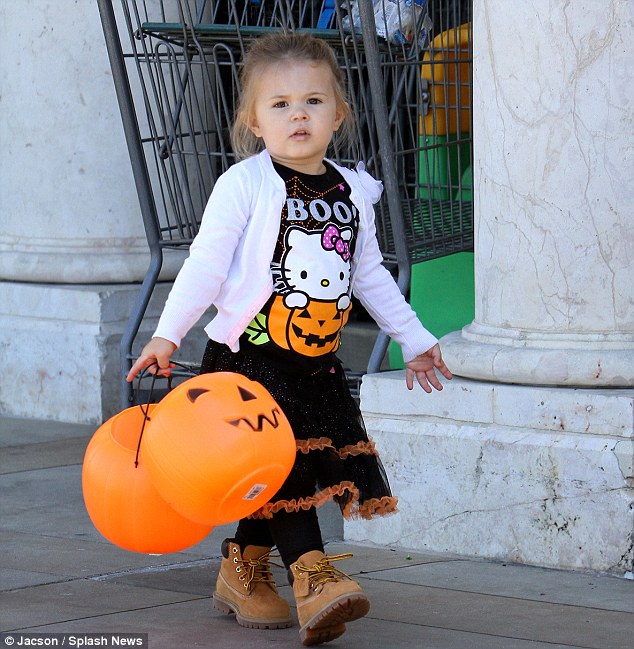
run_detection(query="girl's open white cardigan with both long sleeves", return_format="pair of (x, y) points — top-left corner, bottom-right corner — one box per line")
(154, 150), (438, 362)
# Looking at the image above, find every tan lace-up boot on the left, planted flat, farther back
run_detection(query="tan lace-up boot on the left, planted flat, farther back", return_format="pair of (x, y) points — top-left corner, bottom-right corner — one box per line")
(213, 540), (293, 629)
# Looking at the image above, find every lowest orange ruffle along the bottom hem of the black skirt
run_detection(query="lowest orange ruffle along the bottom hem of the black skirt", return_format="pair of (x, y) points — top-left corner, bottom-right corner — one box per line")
(249, 481), (398, 520)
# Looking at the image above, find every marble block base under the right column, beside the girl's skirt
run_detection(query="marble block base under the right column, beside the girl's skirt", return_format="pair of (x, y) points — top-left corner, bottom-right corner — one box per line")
(345, 372), (634, 575)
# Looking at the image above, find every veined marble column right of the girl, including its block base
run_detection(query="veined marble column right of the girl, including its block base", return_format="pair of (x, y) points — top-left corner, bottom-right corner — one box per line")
(345, 0), (634, 577)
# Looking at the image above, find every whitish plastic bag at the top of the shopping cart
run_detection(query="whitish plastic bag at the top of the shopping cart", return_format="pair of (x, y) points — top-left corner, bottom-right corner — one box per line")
(342, 0), (432, 46)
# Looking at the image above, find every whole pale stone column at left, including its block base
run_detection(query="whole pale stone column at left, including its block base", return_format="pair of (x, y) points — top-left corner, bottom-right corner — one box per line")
(0, 0), (190, 423)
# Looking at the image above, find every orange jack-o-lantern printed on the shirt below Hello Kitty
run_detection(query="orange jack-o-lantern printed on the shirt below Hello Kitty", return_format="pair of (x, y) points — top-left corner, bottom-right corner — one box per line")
(269, 296), (350, 356)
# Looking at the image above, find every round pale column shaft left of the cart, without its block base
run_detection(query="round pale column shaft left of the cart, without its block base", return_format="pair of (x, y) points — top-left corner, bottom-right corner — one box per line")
(0, 0), (148, 284)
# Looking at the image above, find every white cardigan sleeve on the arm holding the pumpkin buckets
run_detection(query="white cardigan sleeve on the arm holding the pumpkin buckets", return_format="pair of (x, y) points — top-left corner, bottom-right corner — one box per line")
(154, 170), (250, 346)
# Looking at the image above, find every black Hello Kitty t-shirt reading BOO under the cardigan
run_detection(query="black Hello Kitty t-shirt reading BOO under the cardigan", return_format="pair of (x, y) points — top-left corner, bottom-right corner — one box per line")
(240, 162), (359, 372)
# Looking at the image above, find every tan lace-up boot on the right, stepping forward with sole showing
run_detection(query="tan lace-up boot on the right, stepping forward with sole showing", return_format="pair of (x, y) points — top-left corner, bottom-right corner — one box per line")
(291, 550), (370, 646)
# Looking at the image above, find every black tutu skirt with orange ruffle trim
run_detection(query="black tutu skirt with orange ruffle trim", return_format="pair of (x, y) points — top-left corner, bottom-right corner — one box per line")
(201, 341), (397, 519)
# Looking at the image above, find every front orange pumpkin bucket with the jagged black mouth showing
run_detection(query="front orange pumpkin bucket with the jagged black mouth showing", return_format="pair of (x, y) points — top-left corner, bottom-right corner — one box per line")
(143, 372), (295, 525)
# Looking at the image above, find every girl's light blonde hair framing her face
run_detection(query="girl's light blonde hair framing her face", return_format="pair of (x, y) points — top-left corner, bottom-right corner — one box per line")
(231, 32), (354, 159)
